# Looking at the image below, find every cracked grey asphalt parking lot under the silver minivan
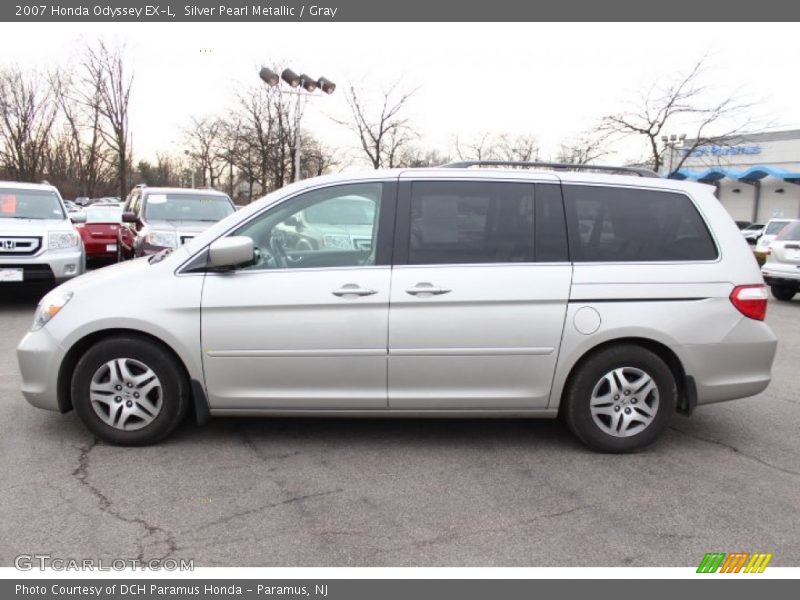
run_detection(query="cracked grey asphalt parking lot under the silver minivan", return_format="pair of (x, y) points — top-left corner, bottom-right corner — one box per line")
(0, 284), (800, 566)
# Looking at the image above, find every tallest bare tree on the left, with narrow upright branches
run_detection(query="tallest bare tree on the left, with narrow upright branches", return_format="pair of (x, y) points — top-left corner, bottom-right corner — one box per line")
(81, 40), (133, 198)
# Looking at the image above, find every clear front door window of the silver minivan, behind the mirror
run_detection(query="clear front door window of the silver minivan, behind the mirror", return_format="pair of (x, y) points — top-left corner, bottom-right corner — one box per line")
(233, 183), (384, 269)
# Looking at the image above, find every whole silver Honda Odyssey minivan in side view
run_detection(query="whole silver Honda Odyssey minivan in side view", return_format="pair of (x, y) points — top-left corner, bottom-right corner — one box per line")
(18, 163), (776, 452)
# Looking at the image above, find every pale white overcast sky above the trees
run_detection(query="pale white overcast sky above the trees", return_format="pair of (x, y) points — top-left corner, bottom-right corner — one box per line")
(0, 23), (800, 166)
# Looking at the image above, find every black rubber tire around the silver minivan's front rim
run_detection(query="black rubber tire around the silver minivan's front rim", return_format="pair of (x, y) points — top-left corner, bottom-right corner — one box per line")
(71, 335), (190, 446)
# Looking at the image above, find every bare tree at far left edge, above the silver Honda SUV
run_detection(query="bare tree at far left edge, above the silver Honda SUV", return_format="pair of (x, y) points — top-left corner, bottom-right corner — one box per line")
(0, 67), (57, 181)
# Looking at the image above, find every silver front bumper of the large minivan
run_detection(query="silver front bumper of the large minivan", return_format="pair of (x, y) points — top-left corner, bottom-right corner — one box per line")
(17, 325), (66, 412)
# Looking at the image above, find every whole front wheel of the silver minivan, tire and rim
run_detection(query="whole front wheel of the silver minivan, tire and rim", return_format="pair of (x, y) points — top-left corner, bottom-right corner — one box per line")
(71, 336), (189, 446)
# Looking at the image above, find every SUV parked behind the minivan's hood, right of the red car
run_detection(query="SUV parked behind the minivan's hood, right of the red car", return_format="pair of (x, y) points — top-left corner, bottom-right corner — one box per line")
(118, 185), (235, 260)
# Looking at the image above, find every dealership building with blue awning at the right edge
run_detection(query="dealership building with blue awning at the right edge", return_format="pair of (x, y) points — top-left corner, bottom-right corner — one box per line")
(665, 129), (800, 223)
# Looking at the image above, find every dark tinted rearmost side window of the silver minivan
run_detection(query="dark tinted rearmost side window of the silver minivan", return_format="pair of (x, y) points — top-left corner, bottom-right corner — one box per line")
(564, 185), (718, 262)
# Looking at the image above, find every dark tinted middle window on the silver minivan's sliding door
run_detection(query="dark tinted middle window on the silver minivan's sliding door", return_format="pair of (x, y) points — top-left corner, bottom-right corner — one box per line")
(408, 181), (534, 265)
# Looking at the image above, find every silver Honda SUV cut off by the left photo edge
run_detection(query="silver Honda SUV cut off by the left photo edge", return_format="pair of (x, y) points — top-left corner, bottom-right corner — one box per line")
(0, 181), (86, 285)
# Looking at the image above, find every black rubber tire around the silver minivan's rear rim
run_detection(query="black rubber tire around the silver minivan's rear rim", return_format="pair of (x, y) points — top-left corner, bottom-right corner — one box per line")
(563, 344), (678, 453)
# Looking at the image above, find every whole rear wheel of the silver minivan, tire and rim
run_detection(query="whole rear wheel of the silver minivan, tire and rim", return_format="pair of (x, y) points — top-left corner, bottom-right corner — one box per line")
(564, 344), (678, 452)
